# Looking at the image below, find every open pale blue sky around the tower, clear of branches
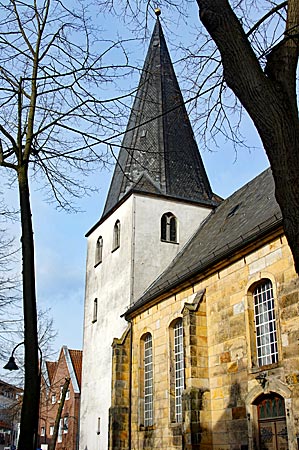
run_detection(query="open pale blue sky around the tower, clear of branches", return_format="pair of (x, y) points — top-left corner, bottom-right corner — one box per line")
(1, 2), (268, 366)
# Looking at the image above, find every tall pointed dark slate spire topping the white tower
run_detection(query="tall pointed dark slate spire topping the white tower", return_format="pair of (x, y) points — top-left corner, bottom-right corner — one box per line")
(103, 12), (218, 216)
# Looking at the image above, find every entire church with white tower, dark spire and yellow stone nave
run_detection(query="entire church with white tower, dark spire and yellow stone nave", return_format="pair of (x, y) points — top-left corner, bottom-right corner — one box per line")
(80, 12), (299, 450)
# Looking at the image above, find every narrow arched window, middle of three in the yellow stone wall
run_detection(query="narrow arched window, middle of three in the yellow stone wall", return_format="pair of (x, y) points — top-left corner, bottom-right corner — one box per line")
(169, 318), (185, 423)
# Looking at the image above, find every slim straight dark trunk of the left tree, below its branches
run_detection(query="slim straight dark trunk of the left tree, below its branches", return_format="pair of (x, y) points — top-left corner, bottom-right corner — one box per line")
(18, 165), (40, 450)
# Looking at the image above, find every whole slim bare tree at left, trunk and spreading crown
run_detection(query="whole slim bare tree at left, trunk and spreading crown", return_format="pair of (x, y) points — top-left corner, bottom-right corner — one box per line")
(0, 0), (138, 450)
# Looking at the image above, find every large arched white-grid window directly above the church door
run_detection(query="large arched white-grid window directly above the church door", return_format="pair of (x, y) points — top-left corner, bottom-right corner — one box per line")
(253, 280), (278, 367)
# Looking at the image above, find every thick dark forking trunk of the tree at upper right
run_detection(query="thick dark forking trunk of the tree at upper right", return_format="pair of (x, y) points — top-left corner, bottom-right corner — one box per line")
(197, 0), (299, 274)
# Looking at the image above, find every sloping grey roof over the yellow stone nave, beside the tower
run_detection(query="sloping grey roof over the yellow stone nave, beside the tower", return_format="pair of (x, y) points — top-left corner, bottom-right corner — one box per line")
(124, 169), (282, 317)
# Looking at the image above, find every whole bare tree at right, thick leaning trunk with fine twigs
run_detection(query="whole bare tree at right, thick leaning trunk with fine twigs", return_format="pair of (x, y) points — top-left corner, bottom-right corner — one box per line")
(109, 0), (299, 273)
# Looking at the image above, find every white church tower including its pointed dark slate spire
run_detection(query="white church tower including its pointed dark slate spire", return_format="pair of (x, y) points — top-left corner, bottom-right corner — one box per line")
(80, 13), (219, 450)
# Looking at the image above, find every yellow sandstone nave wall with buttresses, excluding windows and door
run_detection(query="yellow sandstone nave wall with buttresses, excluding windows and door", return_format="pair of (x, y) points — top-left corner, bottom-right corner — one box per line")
(125, 236), (299, 450)
